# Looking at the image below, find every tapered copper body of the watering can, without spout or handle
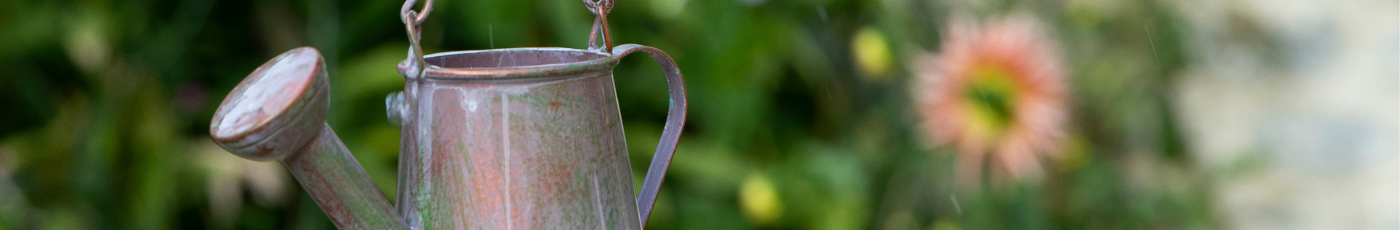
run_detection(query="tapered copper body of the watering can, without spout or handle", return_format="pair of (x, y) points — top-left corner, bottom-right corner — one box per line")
(388, 48), (673, 229)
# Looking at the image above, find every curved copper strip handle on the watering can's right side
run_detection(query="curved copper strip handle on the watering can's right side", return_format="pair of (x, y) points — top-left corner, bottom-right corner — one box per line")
(612, 43), (686, 227)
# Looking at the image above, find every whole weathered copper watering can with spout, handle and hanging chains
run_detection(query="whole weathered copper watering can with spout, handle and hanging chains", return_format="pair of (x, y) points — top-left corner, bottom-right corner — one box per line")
(210, 0), (686, 229)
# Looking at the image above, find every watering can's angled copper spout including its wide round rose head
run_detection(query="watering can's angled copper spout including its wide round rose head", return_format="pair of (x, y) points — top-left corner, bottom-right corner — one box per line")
(209, 48), (407, 229)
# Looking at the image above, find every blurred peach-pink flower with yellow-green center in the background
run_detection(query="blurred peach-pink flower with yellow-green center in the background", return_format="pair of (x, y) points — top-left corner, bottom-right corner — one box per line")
(911, 15), (1068, 184)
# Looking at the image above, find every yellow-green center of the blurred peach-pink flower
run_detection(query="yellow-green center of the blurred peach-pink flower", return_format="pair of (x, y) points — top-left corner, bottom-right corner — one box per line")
(963, 65), (1016, 140)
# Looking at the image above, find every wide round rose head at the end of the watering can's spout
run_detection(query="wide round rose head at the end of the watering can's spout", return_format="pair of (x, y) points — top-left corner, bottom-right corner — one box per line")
(209, 48), (329, 160)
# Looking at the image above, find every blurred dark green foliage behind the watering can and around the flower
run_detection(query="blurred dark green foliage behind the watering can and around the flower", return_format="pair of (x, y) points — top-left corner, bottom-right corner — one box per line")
(0, 0), (1217, 230)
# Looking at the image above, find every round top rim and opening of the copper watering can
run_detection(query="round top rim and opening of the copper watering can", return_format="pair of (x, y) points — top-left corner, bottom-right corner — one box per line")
(396, 48), (620, 81)
